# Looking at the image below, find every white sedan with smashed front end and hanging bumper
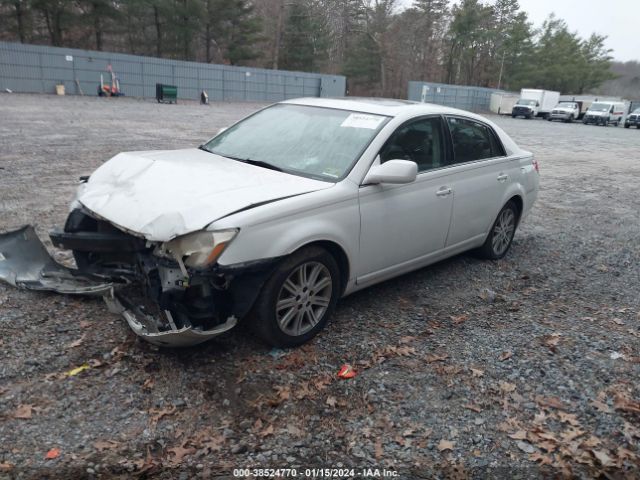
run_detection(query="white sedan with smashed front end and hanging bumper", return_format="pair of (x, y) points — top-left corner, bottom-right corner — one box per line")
(0, 98), (539, 346)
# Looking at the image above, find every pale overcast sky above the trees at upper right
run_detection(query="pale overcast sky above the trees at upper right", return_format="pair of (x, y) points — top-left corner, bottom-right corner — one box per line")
(398, 0), (640, 62)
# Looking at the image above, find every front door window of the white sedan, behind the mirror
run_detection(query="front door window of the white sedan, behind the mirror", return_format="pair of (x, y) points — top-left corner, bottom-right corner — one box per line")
(380, 117), (446, 172)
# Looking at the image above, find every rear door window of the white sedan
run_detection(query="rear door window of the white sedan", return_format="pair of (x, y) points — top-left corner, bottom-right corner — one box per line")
(447, 117), (505, 163)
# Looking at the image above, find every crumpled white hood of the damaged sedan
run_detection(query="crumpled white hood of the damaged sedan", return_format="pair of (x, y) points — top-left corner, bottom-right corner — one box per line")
(78, 148), (333, 241)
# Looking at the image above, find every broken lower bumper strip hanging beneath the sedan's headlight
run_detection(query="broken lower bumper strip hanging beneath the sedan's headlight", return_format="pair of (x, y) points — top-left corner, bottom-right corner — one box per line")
(104, 290), (237, 347)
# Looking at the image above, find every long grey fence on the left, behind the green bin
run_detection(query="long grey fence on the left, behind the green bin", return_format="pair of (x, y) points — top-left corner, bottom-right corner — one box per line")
(0, 42), (346, 102)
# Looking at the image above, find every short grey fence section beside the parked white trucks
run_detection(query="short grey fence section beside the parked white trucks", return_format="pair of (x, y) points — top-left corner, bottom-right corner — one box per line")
(409, 82), (503, 112)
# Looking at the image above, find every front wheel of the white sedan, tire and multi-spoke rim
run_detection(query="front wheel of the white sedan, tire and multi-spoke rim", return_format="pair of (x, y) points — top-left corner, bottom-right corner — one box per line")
(252, 246), (341, 348)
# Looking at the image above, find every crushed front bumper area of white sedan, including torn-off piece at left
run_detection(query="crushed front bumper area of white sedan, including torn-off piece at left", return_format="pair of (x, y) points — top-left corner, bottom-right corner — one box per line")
(0, 226), (279, 347)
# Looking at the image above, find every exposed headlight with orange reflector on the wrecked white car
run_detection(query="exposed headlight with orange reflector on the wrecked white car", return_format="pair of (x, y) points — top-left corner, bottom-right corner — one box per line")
(159, 228), (238, 268)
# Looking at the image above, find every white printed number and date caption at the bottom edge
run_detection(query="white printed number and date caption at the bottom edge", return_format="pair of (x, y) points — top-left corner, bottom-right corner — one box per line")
(233, 468), (398, 478)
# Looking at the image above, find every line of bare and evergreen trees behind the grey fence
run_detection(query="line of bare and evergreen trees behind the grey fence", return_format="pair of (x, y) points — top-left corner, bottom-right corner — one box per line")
(0, 0), (615, 97)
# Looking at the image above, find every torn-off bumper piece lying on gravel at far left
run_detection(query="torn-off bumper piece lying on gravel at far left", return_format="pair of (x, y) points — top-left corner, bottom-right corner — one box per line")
(0, 225), (113, 296)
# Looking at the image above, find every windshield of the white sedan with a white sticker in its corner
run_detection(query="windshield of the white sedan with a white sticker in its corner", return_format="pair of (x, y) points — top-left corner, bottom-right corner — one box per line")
(202, 104), (389, 181)
